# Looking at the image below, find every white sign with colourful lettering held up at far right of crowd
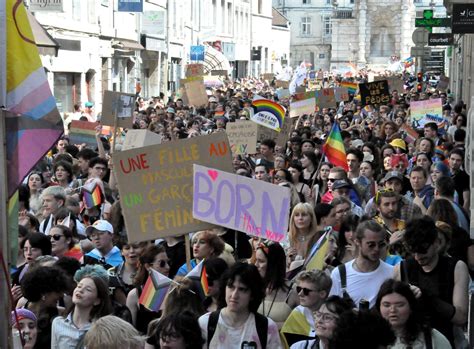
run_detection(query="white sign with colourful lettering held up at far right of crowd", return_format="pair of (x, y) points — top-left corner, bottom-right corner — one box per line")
(410, 98), (445, 129)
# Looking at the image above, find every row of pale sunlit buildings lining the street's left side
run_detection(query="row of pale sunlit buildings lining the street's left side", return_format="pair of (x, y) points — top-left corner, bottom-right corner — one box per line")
(27, 0), (290, 113)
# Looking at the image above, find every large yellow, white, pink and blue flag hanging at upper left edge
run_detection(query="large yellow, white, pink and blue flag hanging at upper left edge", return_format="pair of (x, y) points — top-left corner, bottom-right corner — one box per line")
(5, 0), (64, 197)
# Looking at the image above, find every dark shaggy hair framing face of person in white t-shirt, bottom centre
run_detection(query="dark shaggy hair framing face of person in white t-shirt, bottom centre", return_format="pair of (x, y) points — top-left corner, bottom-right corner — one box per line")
(218, 262), (265, 313)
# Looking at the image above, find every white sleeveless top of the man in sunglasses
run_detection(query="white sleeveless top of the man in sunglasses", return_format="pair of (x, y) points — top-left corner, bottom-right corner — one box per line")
(329, 259), (393, 308)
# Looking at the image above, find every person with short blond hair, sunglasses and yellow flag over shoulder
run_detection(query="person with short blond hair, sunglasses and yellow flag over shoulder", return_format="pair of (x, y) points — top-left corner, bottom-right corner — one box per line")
(281, 269), (332, 346)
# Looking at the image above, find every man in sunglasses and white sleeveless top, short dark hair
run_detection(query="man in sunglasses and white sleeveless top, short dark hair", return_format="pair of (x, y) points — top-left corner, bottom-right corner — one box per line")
(330, 220), (393, 307)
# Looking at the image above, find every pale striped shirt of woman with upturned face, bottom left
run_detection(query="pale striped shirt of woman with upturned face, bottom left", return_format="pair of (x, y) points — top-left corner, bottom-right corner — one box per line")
(51, 312), (92, 349)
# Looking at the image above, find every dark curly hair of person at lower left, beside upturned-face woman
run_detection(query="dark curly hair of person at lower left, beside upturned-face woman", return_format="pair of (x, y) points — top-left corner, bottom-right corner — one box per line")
(21, 266), (68, 302)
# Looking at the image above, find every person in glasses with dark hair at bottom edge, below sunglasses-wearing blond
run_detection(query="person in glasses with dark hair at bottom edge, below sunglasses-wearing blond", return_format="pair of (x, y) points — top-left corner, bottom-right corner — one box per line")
(290, 296), (355, 349)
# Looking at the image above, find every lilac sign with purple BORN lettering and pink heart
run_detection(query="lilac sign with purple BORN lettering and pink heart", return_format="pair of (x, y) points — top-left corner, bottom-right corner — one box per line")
(193, 165), (290, 242)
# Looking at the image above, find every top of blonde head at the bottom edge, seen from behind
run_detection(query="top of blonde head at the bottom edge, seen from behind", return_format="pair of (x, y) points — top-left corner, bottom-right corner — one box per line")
(84, 315), (146, 349)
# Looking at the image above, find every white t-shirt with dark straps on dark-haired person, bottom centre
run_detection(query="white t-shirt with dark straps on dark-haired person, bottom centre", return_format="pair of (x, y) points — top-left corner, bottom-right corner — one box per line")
(199, 312), (283, 349)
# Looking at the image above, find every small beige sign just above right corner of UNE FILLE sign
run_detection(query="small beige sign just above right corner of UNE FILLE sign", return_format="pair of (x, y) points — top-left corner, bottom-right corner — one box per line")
(226, 120), (258, 155)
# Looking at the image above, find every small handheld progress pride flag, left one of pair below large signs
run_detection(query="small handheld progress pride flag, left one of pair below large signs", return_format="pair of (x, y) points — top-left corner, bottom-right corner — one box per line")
(138, 269), (173, 312)
